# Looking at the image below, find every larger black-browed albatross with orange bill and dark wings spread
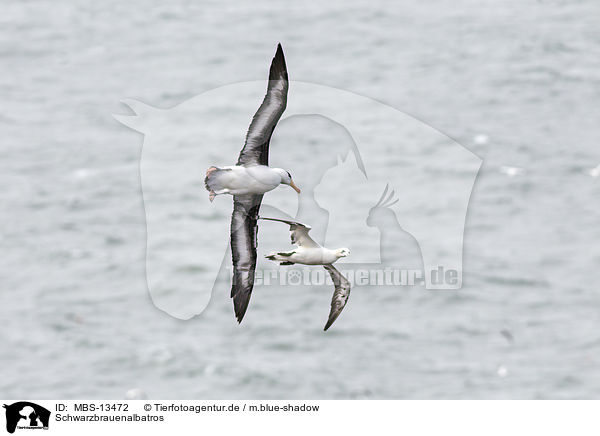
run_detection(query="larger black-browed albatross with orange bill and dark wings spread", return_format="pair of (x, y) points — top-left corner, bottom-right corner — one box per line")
(204, 44), (300, 322)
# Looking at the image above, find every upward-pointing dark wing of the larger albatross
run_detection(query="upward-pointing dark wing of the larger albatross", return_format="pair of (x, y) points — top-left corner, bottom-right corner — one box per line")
(237, 44), (288, 166)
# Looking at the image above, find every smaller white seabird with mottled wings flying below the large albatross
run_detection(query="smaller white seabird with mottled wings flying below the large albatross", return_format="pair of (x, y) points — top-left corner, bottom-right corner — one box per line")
(260, 217), (350, 330)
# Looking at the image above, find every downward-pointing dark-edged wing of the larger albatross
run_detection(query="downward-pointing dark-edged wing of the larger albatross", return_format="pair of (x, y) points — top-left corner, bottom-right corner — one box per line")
(231, 195), (263, 322)
